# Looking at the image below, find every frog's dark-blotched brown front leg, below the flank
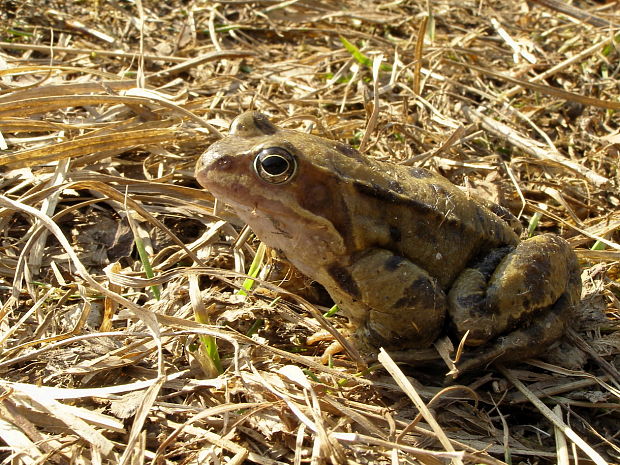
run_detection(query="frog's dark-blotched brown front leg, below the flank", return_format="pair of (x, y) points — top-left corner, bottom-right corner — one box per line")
(349, 249), (446, 347)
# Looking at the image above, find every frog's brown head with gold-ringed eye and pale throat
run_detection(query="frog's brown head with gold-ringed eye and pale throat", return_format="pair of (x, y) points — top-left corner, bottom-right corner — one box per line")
(196, 112), (365, 268)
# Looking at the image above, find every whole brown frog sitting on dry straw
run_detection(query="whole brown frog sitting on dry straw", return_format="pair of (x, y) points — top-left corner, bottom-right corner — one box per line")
(196, 112), (581, 370)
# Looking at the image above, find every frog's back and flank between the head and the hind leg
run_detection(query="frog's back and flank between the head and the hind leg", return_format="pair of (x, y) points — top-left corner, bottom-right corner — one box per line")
(322, 150), (519, 287)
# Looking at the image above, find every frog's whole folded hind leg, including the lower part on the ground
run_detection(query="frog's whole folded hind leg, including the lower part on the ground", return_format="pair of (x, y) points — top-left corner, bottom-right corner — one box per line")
(448, 234), (581, 370)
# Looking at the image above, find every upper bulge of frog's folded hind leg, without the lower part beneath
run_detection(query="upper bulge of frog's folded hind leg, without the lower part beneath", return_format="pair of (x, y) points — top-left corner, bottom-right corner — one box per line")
(448, 234), (581, 344)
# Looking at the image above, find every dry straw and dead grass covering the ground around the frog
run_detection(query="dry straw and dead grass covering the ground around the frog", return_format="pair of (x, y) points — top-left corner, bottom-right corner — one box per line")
(0, 0), (620, 464)
